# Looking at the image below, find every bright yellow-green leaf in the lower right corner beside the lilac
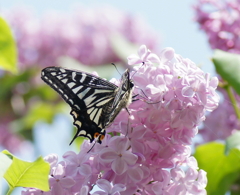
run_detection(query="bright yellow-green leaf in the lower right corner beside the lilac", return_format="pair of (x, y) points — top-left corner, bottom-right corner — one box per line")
(194, 142), (240, 195)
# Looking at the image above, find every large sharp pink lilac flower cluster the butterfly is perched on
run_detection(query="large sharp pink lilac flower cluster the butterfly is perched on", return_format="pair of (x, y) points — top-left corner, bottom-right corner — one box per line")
(22, 45), (219, 195)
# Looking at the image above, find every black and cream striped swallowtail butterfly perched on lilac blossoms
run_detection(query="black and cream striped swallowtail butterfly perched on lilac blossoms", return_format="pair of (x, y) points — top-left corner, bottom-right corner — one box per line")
(41, 67), (134, 145)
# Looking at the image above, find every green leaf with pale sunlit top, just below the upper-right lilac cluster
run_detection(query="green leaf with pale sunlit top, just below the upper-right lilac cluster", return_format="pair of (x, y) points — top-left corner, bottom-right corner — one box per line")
(212, 50), (240, 95)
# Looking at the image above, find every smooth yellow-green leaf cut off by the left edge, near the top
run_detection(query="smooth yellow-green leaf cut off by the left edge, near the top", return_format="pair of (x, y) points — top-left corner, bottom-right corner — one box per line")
(0, 17), (17, 73)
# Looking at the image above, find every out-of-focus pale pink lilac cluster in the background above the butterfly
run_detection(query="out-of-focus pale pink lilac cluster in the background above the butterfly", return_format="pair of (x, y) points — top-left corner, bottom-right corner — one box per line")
(3, 7), (158, 67)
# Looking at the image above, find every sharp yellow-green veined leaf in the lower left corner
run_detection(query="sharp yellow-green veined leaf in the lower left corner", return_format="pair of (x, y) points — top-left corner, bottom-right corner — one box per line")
(3, 150), (50, 191)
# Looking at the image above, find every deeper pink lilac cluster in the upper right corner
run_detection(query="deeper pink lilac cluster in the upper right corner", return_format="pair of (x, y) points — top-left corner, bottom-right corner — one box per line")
(194, 0), (240, 53)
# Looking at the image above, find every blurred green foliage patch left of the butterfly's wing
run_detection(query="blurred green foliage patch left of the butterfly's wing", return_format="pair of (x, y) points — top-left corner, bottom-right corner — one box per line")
(0, 67), (67, 140)
